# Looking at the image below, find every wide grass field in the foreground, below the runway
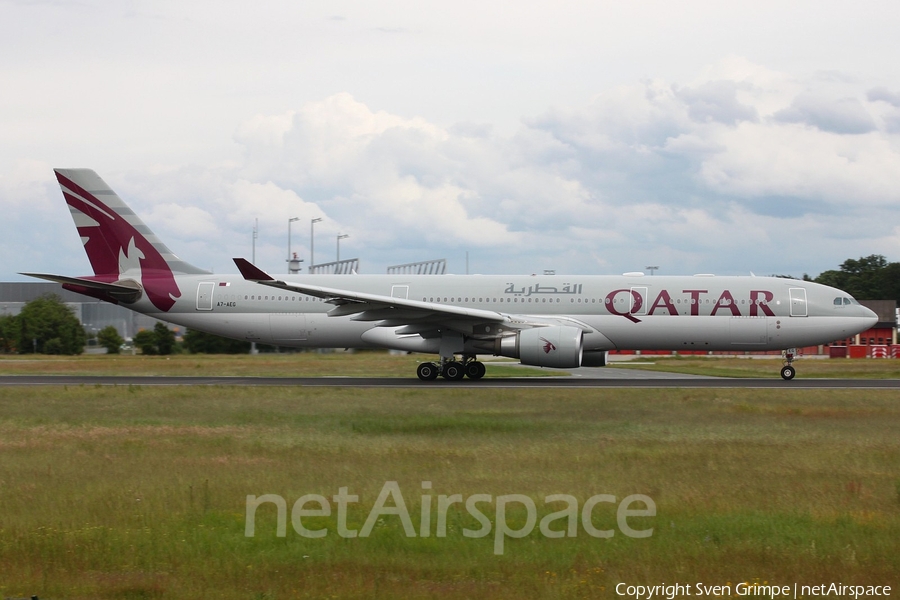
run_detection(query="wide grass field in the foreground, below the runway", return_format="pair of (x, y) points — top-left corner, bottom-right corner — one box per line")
(0, 370), (900, 599)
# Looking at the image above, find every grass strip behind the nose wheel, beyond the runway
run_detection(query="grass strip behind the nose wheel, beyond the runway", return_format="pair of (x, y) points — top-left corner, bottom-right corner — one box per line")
(611, 356), (900, 379)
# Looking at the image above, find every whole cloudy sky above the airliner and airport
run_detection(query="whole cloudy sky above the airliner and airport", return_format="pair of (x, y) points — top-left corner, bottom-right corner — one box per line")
(0, 0), (900, 280)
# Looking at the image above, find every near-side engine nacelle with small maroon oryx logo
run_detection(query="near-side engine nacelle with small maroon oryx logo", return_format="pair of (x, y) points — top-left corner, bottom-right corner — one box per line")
(494, 325), (584, 369)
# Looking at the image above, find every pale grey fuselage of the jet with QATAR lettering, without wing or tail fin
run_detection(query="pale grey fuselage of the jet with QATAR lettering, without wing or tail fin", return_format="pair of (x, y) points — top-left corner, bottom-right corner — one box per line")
(126, 275), (877, 352)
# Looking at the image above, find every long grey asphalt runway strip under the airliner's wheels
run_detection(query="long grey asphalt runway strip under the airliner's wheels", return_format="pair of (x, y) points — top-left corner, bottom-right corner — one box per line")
(0, 369), (900, 390)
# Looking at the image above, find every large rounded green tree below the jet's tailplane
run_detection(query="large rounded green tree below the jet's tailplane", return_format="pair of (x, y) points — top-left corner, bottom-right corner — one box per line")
(16, 294), (87, 354)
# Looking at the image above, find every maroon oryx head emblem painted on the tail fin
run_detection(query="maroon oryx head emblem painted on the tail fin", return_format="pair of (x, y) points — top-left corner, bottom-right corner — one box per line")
(56, 172), (181, 311)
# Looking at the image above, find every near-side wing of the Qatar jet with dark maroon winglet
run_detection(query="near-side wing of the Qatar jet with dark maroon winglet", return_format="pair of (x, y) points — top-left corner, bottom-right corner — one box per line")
(234, 258), (591, 338)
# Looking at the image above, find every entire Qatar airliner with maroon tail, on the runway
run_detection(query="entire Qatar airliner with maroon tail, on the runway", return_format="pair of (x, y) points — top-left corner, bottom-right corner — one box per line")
(24, 169), (877, 380)
